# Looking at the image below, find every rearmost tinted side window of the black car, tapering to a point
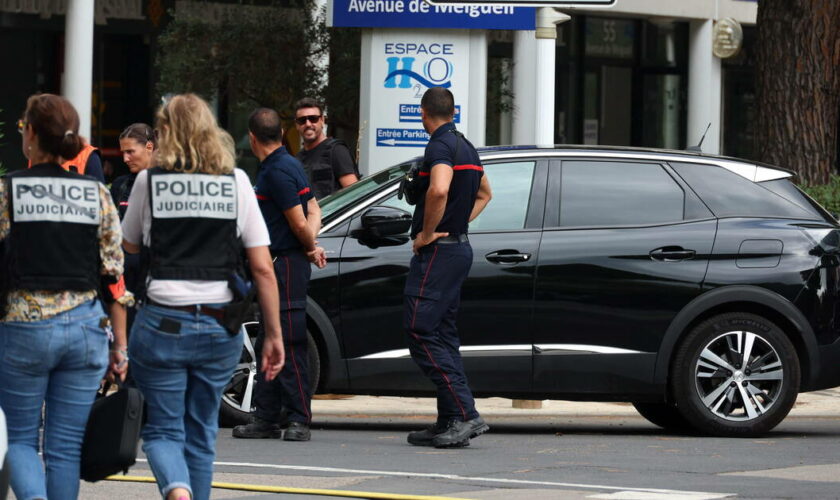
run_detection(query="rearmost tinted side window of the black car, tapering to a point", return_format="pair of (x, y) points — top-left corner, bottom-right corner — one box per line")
(671, 163), (814, 219)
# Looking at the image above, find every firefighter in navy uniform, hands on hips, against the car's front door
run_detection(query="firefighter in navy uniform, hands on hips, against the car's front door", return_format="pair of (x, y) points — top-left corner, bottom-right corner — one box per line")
(404, 87), (491, 448)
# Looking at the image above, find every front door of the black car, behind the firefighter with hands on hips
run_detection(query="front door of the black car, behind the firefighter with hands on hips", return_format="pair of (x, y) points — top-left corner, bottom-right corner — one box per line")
(340, 159), (547, 394)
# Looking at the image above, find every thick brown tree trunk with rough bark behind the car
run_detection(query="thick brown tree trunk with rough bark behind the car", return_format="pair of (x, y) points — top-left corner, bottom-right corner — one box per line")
(755, 0), (840, 184)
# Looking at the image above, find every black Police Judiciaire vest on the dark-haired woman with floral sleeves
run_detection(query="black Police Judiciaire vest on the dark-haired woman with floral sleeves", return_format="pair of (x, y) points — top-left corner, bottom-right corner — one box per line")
(4, 163), (101, 291)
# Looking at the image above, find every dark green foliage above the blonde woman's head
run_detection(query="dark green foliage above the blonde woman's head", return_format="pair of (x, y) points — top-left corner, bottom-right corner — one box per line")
(157, 0), (326, 118)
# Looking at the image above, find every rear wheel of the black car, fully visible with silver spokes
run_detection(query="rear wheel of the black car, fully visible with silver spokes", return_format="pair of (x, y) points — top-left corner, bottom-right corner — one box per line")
(670, 313), (800, 437)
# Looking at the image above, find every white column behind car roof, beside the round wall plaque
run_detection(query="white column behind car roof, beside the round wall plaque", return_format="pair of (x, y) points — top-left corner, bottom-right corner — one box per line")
(686, 19), (722, 154)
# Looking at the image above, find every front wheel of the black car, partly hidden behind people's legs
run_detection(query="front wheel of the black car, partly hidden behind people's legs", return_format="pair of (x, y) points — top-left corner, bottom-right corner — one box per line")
(219, 321), (321, 427)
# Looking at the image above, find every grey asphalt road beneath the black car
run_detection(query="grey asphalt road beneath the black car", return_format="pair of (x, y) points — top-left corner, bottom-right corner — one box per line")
(62, 415), (840, 500)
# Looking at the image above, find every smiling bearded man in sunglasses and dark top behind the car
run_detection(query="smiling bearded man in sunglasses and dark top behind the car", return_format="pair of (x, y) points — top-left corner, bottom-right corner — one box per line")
(295, 97), (359, 200)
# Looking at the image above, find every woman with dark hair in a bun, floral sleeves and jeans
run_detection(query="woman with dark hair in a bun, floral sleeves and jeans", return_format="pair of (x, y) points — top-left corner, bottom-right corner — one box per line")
(0, 94), (128, 499)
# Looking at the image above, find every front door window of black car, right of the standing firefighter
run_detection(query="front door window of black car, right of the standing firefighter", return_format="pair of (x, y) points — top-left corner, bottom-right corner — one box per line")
(470, 161), (536, 232)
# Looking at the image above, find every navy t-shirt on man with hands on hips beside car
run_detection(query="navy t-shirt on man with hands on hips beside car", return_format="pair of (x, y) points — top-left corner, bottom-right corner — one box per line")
(411, 122), (484, 238)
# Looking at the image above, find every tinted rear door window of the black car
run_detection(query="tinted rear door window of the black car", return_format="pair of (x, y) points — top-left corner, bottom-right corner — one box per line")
(560, 161), (685, 226)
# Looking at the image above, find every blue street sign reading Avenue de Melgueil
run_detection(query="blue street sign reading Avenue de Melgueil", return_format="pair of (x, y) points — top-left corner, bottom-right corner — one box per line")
(331, 0), (536, 30)
